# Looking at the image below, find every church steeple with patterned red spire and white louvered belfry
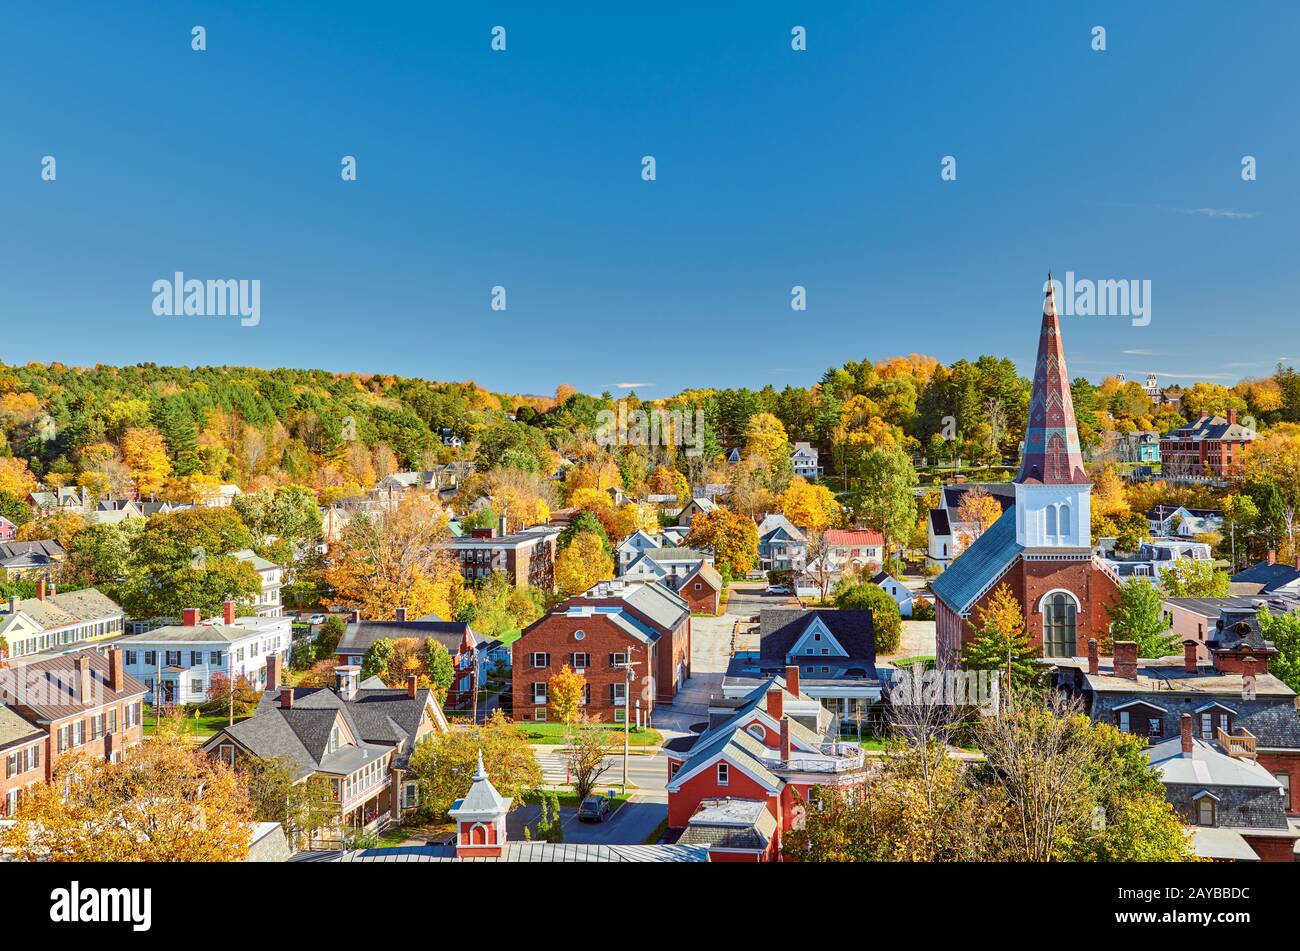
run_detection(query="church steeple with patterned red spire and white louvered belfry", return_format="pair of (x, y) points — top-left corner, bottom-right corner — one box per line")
(1015, 273), (1092, 550)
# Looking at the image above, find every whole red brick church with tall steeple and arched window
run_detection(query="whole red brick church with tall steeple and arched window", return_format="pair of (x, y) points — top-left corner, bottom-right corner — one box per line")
(932, 275), (1119, 664)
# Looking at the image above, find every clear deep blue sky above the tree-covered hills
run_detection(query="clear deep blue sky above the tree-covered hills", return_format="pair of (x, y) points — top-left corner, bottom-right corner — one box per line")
(0, 0), (1300, 398)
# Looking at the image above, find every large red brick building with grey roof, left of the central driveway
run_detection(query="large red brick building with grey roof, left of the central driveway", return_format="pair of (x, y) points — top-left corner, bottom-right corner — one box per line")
(511, 582), (690, 722)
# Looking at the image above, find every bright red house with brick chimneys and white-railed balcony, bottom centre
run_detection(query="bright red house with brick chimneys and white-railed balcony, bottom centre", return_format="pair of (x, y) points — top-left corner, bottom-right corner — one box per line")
(666, 666), (866, 861)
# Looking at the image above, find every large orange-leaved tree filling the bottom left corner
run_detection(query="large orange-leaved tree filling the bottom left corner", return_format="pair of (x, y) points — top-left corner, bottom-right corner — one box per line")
(0, 731), (254, 863)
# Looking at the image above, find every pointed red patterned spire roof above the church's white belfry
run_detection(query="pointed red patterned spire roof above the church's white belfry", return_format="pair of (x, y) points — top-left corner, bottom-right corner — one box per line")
(1015, 274), (1088, 486)
